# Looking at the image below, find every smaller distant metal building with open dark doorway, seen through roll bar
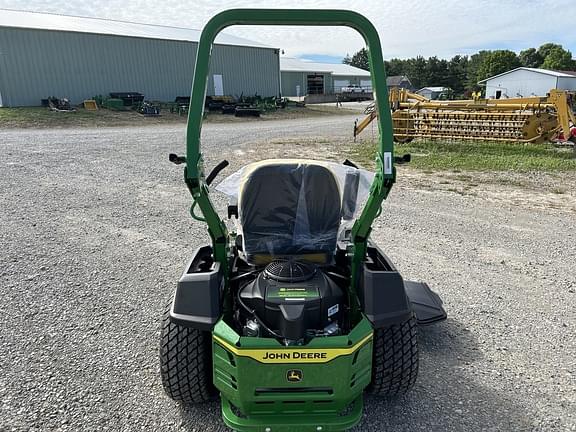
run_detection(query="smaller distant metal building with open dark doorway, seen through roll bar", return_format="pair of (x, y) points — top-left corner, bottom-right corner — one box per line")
(280, 57), (372, 96)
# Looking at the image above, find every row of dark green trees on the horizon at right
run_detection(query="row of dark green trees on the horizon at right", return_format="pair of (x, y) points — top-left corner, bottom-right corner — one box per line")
(342, 43), (576, 96)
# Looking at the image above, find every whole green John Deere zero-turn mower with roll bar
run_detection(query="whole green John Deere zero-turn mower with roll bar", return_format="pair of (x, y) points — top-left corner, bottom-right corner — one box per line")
(160, 9), (446, 432)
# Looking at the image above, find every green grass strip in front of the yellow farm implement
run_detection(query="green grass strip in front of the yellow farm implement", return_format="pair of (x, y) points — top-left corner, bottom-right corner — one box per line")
(353, 140), (576, 172)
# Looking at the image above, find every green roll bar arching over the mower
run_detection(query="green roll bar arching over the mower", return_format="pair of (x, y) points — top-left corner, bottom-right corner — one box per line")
(184, 9), (396, 316)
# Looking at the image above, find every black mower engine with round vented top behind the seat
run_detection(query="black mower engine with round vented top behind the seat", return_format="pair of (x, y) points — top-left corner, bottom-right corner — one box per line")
(239, 260), (343, 344)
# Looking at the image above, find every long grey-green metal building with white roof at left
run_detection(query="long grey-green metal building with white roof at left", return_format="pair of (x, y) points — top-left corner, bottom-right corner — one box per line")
(0, 10), (280, 106)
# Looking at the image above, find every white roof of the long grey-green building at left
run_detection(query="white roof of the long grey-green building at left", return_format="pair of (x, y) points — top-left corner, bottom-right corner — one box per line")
(0, 9), (271, 48)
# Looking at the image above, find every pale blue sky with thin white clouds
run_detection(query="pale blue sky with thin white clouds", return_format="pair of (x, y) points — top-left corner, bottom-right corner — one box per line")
(0, 0), (576, 62)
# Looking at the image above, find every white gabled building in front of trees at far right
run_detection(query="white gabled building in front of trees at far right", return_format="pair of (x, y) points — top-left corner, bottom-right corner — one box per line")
(478, 67), (576, 99)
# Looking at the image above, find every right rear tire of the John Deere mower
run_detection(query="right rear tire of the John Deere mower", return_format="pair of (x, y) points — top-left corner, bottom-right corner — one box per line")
(368, 315), (418, 397)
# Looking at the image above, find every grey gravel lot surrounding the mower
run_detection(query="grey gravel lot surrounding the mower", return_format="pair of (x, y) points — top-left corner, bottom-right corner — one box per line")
(0, 116), (576, 432)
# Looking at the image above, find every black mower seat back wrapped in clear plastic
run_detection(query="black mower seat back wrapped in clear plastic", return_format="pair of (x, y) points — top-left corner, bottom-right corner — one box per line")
(238, 161), (341, 261)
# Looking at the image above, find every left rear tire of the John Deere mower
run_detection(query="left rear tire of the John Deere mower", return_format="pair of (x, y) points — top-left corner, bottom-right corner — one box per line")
(160, 303), (217, 404)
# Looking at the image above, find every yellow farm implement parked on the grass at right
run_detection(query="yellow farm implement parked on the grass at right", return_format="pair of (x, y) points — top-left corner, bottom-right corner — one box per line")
(354, 88), (576, 144)
